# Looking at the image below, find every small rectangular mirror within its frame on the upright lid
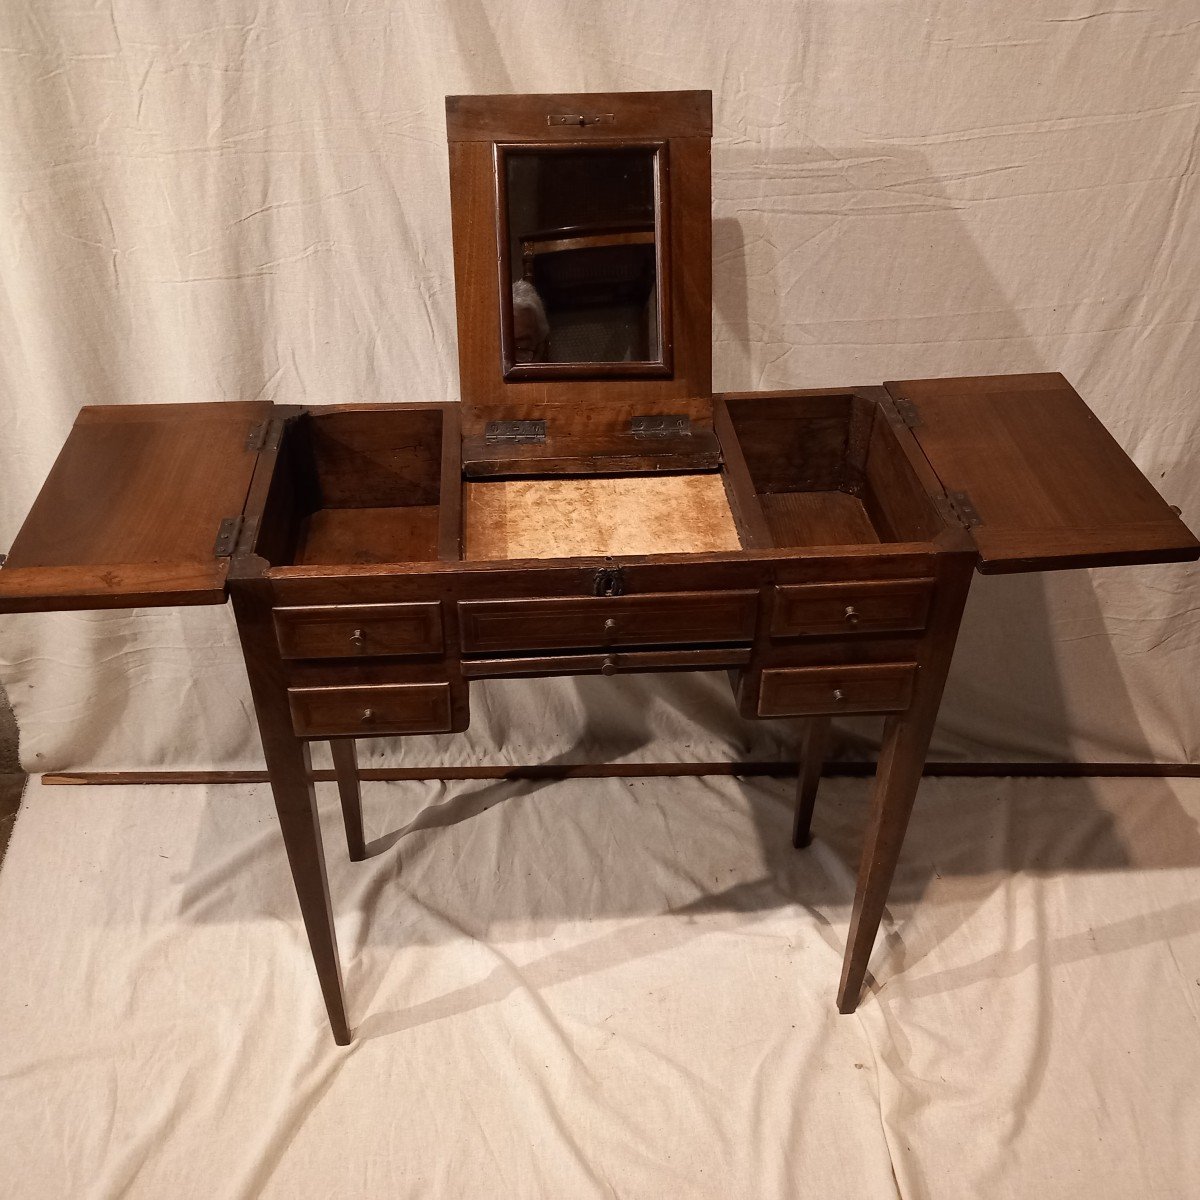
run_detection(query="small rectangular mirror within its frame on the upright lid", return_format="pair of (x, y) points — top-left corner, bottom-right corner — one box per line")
(497, 145), (670, 378)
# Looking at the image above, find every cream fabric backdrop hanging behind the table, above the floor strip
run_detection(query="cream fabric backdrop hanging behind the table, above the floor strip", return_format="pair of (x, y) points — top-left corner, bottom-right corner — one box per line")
(0, 0), (1200, 769)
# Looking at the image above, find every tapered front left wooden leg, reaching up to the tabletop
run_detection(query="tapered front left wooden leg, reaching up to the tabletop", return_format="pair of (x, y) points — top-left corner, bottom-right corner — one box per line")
(230, 584), (350, 1046)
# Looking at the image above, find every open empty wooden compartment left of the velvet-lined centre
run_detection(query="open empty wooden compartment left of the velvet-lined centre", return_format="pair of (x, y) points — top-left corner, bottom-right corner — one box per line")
(259, 404), (458, 566)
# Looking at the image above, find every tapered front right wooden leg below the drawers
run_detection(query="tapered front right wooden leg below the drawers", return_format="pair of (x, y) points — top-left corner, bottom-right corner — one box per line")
(838, 710), (936, 1013)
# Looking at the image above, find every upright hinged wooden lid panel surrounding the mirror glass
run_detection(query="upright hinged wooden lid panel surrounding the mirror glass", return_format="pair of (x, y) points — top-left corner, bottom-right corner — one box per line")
(446, 91), (720, 474)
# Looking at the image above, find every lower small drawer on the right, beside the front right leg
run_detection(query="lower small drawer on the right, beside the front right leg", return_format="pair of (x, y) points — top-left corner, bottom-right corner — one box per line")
(758, 662), (917, 716)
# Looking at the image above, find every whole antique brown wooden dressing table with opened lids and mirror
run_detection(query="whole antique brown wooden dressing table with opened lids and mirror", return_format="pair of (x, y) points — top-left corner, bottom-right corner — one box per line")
(0, 92), (1200, 1044)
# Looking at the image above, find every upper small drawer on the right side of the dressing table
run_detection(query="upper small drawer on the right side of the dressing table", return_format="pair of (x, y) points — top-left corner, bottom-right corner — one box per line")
(770, 580), (934, 637)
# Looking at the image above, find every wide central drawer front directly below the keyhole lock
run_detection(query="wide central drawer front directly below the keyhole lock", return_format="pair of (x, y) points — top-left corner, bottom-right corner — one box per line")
(458, 592), (758, 654)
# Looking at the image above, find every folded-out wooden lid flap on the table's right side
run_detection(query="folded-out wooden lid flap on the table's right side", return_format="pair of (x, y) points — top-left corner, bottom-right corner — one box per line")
(886, 373), (1200, 574)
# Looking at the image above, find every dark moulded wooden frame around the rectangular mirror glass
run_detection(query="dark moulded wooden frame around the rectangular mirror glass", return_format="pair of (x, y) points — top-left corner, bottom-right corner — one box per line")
(492, 138), (672, 380)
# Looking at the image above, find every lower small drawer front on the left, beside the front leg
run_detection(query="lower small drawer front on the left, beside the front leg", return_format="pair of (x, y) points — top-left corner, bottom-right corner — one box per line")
(288, 683), (451, 738)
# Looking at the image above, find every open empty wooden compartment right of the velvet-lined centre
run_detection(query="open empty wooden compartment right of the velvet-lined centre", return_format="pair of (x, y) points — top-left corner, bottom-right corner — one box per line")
(726, 392), (942, 548)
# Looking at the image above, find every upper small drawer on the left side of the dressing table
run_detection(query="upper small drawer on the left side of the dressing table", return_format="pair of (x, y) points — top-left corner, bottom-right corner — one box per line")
(275, 601), (443, 659)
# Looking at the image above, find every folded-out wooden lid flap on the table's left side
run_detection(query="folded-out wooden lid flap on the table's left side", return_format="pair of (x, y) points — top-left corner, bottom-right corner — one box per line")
(0, 401), (271, 612)
